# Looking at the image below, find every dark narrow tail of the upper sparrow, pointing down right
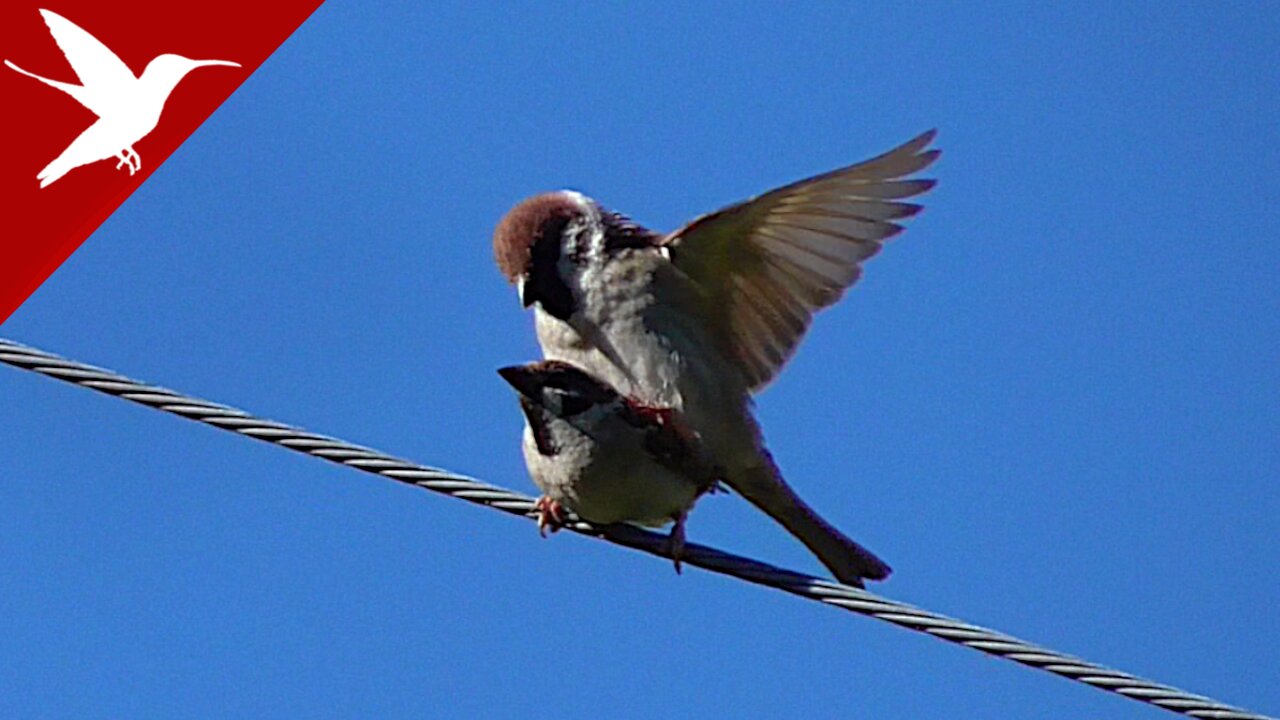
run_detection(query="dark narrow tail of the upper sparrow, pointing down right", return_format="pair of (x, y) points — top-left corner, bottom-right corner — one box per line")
(728, 454), (892, 588)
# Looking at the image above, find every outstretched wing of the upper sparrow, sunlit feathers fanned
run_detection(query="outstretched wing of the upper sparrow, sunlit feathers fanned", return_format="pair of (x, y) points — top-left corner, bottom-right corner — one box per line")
(662, 131), (938, 391)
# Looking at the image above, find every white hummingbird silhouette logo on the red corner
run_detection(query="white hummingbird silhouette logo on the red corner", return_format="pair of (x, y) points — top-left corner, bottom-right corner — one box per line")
(4, 10), (241, 187)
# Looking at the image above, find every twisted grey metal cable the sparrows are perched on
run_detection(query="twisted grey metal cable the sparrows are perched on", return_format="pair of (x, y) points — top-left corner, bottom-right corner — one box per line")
(0, 338), (1275, 720)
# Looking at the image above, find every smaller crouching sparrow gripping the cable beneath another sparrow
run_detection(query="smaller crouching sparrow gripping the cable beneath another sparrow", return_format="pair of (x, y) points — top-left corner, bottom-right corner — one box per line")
(498, 360), (719, 573)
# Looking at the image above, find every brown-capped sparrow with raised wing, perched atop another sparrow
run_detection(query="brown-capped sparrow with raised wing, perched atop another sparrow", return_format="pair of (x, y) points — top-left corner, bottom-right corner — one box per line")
(493, 131), (938, 587)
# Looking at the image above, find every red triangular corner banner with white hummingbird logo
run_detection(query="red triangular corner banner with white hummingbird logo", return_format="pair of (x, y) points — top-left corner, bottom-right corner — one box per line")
(0, 0), (323, 323)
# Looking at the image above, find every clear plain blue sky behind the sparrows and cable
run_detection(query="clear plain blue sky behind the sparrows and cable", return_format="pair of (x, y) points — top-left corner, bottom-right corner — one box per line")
(0, 1), (1280, 719)
